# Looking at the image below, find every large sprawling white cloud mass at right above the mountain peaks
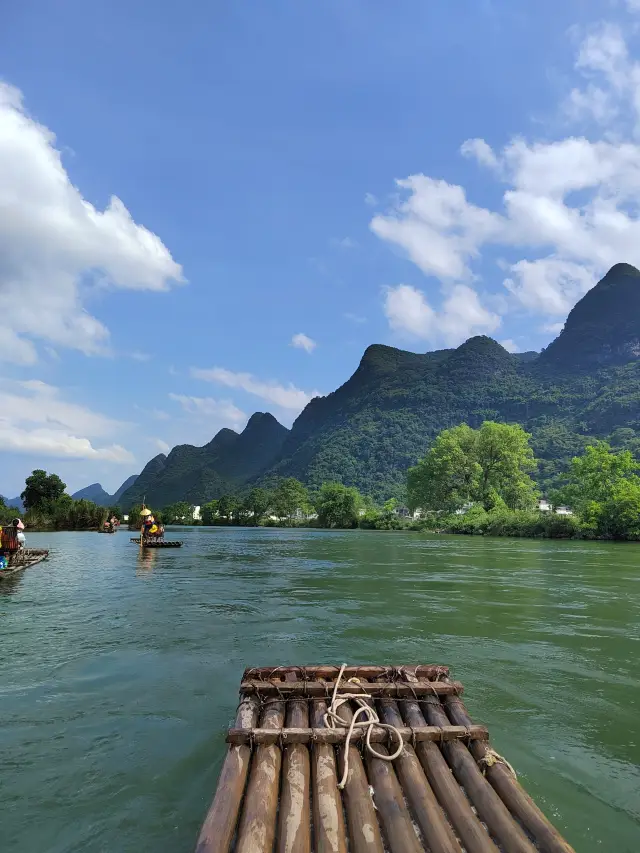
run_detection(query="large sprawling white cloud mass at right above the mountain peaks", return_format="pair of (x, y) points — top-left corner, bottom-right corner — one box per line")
(370, 20), (640, 332)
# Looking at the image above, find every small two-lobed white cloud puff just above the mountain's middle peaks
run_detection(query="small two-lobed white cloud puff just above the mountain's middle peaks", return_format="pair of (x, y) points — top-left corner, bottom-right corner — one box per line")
(384, 284), (500, 346)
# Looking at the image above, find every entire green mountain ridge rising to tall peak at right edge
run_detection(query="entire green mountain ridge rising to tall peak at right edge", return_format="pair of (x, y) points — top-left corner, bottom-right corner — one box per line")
(123, 264), (640, 506)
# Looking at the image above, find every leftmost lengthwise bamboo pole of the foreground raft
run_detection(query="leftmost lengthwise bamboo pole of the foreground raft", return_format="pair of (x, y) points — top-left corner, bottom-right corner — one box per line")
(196, 696), (258, 853)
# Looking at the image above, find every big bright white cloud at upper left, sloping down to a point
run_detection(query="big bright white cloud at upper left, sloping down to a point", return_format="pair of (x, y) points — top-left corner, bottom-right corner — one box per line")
(0, 83), (182, 364)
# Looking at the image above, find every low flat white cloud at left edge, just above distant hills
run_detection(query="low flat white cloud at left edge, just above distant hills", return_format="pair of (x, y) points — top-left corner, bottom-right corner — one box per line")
(0, 380), (135, 463)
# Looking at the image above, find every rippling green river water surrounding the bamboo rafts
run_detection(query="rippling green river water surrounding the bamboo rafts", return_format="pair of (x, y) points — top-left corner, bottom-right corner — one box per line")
(0, 528), (640, 853)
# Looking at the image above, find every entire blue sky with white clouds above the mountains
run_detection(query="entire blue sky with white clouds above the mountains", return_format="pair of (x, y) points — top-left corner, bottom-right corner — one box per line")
(0, 0), (640, 497)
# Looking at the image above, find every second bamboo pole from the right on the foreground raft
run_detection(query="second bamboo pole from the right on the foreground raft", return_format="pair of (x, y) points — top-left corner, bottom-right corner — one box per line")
(422, 696), (536, 853)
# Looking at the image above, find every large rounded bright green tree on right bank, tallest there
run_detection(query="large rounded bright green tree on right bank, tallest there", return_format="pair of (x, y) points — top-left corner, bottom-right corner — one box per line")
(407, 421), (537, 512)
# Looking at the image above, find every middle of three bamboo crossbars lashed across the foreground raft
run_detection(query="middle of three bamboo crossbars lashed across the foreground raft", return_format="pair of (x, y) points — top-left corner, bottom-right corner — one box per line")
(240, 679), (463, 699)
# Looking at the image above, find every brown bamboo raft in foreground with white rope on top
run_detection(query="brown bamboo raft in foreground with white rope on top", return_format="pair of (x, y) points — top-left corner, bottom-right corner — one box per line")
(196, 665), (574, 853)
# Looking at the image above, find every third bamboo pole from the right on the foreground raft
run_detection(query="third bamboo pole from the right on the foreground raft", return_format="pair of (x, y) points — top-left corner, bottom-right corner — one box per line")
(402, 700), (498, 853)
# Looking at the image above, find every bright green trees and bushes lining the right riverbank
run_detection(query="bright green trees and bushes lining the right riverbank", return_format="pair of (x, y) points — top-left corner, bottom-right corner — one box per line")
(407, 421), (640, 539)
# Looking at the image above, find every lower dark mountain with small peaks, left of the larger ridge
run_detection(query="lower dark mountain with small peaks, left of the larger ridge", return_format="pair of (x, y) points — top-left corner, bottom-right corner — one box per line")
(120, 412), (289, 507)
